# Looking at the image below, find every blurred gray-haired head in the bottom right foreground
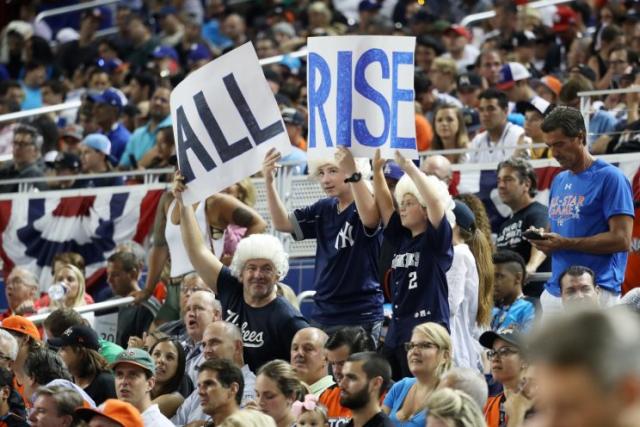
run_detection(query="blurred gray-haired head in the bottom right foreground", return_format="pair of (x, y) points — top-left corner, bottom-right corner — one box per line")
(528, 307), (640, 427)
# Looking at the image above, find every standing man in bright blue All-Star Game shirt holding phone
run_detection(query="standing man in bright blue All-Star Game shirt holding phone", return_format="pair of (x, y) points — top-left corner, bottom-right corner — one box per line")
(529, 107), (634, 313)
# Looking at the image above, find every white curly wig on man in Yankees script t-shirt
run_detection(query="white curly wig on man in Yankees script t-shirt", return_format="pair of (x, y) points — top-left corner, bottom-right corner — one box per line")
(229, 234), (289, 280)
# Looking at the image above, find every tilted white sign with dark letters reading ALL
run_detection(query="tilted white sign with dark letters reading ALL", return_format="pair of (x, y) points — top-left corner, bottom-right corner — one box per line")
(171, 43), (291, 204)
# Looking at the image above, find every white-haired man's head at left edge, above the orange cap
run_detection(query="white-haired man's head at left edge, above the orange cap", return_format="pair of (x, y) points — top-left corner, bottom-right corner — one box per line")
(0, 267), (39, 320)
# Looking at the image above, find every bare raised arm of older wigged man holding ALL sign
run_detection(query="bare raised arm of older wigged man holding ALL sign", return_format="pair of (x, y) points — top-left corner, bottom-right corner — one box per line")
(172, 172), (222, 293)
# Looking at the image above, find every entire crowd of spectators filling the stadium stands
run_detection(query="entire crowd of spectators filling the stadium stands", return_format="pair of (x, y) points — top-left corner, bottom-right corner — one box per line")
(0, 0), (640, 427)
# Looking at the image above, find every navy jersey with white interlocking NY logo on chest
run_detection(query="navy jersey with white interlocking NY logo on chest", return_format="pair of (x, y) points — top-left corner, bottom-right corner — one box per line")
(290, 197), (383, 326)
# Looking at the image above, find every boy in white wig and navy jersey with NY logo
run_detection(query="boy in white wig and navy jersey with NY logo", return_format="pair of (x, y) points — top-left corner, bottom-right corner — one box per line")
(262, 147), (383, 342)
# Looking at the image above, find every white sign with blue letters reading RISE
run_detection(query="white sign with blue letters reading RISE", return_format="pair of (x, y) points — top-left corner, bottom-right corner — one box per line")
(307, 36), (418, 158)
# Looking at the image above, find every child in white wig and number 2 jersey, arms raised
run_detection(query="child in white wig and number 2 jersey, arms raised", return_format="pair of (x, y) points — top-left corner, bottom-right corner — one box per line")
(374, 150), (455, 379)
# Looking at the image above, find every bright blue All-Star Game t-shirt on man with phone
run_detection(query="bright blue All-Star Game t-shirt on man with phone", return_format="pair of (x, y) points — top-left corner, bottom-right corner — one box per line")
(545, 160), (634, 296)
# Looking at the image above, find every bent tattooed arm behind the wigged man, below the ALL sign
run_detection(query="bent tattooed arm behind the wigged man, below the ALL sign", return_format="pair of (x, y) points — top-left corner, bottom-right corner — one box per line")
(206, 193), (267, 236)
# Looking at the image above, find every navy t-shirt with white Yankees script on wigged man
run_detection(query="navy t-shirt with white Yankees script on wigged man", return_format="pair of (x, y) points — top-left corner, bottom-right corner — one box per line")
(217, 267), (309, 372)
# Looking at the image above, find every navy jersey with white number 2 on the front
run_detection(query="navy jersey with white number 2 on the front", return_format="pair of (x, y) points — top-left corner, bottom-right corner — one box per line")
(384, 212), (453, 348)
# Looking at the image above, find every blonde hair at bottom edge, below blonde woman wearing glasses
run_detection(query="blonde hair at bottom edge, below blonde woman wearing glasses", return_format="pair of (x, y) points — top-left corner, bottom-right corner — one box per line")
(426, 388), (487, 427)
